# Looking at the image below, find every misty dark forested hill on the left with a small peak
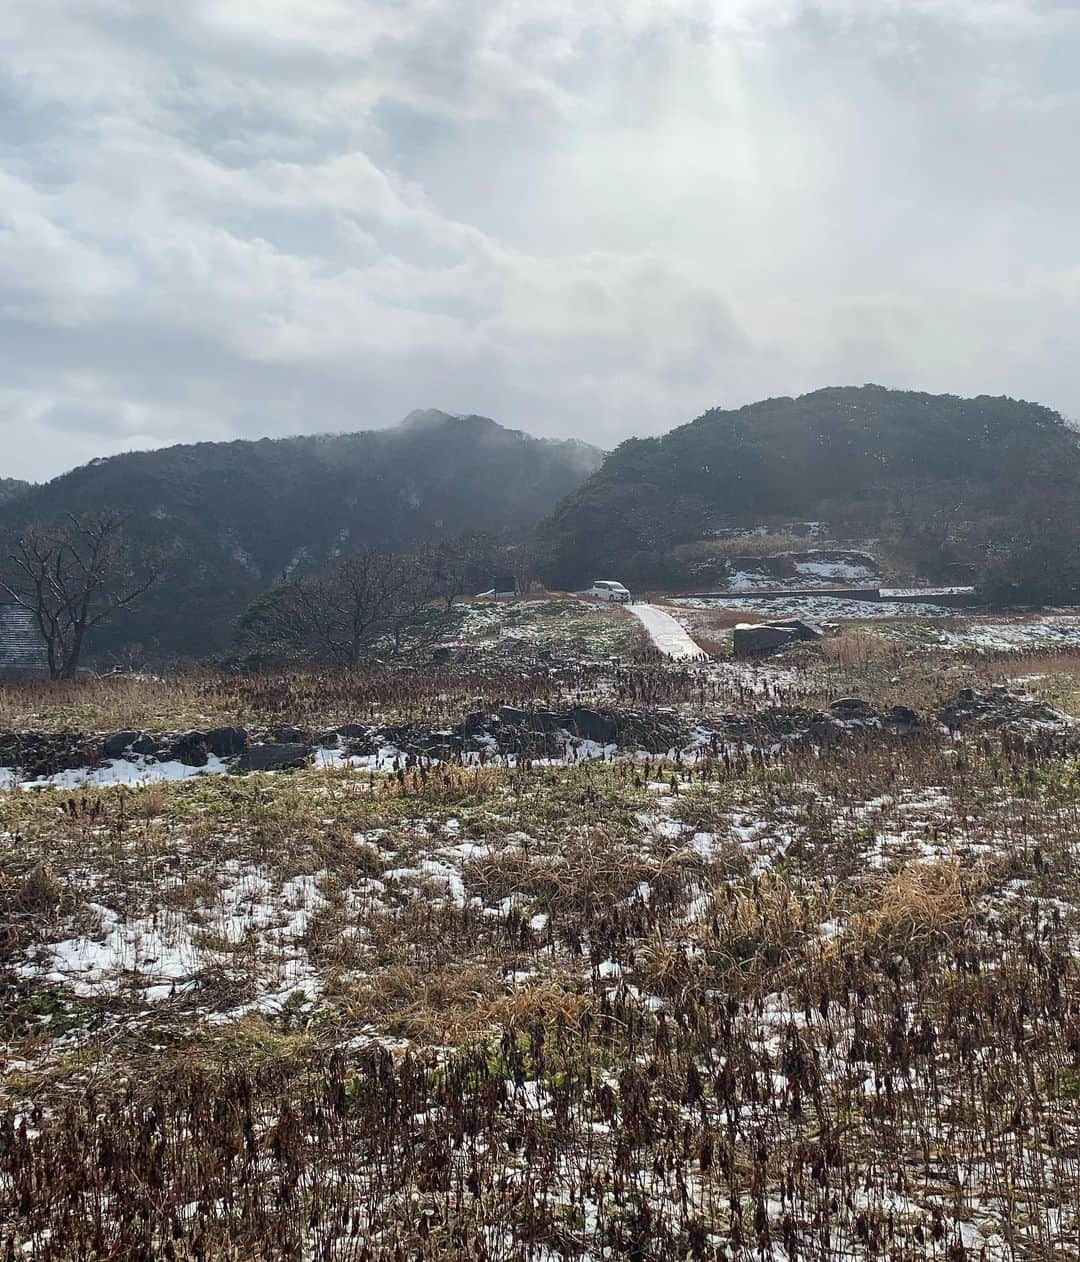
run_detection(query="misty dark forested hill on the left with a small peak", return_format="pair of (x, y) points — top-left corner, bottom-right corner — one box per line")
(0, 411), (603, 671)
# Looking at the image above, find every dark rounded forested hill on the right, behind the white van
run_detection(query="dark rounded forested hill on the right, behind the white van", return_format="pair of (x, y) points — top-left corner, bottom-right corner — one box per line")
(545, 385), (1080, 584)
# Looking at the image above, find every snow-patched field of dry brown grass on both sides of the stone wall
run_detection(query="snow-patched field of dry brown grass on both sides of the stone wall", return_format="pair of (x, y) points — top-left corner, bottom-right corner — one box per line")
(0, 632), (1080, 1262)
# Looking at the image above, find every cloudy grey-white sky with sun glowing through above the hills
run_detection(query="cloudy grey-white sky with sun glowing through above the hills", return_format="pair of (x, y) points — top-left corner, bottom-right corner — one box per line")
(0, 0), (1080, 478)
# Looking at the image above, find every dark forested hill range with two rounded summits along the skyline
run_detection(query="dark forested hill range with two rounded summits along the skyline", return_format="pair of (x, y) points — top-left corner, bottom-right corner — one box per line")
(0, 386), (1080, 661)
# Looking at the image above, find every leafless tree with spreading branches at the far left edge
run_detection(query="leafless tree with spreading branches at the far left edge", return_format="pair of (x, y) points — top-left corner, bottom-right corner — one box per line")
(0, 511), (160, 679)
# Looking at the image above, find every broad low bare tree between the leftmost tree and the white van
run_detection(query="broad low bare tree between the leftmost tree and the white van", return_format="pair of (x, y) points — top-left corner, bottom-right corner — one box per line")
(241, 548), (452, 666)
